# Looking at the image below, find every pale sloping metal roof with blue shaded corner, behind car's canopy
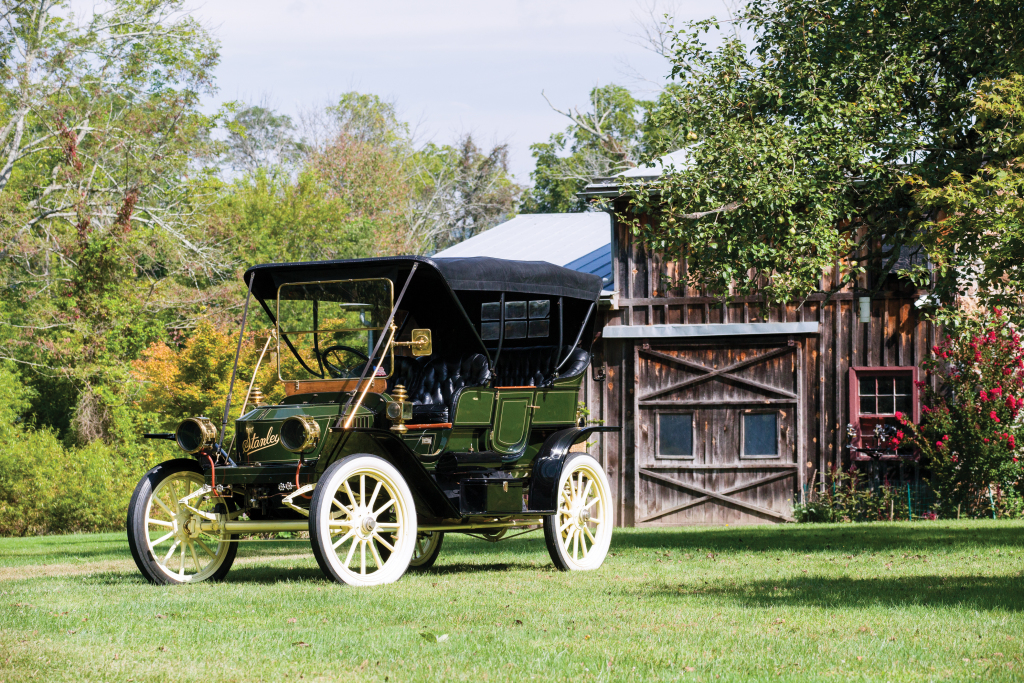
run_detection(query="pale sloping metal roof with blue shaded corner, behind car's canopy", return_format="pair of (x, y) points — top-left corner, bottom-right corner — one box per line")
(433, 212), (611, 289)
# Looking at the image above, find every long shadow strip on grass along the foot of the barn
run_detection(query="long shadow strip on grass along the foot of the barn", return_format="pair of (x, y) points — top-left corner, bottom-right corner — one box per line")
(611, 522), (1024, 553)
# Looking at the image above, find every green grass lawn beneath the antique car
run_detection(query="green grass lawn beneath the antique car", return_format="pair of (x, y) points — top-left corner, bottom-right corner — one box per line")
(0, 521), (1024, 682)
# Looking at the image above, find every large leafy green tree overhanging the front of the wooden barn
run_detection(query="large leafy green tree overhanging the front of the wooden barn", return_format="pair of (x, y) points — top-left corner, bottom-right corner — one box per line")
(628, 0), (1024, 301)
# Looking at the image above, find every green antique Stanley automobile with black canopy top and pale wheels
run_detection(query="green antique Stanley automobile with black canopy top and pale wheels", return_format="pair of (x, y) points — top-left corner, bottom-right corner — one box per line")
(128, 257), (614, 586)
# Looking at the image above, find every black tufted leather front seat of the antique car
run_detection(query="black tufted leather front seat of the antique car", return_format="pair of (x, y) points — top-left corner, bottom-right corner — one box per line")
(387, 353), (490, 424)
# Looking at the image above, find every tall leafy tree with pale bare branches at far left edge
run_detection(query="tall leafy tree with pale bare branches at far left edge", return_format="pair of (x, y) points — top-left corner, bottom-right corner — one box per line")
(0, 0), (223, 440)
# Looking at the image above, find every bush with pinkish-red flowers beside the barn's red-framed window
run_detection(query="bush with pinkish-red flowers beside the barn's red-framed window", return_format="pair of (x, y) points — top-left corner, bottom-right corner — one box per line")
(896, 308), (1024, 515)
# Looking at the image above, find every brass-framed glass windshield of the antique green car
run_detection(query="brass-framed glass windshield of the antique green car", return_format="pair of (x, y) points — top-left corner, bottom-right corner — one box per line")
(278, 278), (393, 381)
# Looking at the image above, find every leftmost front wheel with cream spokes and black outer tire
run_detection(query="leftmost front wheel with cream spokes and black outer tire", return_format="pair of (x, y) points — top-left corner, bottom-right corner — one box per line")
(128, 459), (239, 584)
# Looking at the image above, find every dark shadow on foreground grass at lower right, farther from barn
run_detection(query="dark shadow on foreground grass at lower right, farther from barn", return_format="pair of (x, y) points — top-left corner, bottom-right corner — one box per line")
(662, 575), (1024, 611)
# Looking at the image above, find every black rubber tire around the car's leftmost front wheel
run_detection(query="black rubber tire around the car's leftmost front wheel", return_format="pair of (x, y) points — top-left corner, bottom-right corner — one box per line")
(127, 458), (239, 586)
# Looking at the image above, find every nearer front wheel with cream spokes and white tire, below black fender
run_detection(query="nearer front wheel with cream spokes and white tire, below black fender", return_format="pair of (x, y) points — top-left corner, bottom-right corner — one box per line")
(309, 455), (417, 586)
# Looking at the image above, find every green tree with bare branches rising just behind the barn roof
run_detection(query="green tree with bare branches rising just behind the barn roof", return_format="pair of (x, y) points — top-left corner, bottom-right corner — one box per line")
(523, 85), (671, 213)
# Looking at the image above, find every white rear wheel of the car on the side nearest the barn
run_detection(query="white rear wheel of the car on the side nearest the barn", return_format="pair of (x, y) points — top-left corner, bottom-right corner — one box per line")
(544, 453), (614, 571)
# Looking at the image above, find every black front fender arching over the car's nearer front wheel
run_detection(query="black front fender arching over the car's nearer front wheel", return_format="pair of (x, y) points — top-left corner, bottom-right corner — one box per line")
(316, 428), (462, 519)
